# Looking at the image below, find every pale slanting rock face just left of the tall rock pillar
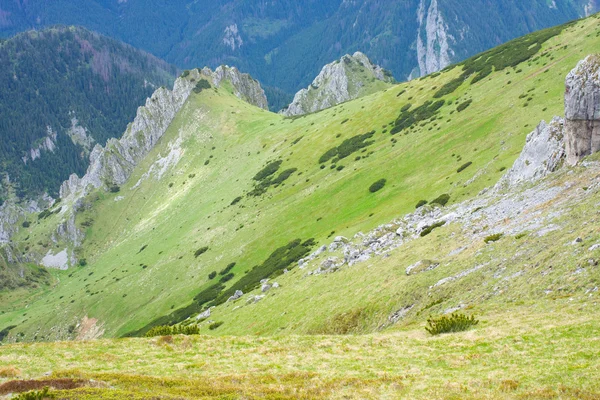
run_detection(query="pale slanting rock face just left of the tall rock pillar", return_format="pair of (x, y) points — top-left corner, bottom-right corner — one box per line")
(497, 117), (565, 187)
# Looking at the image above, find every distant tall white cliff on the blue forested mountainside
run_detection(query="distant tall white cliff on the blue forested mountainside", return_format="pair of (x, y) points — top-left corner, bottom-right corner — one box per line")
(417, 0), (455, 75)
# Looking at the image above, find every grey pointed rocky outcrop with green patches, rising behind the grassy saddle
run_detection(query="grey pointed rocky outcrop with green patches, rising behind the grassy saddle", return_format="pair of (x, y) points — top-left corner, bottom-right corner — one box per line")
(282, 52), (394, 117)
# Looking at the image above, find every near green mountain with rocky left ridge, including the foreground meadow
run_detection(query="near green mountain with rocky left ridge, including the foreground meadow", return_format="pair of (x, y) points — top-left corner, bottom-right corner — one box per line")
(0, 11), (600, 399)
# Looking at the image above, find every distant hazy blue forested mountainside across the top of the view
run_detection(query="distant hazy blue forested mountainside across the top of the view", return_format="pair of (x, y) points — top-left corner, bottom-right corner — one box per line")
(0, 0), (598, 101)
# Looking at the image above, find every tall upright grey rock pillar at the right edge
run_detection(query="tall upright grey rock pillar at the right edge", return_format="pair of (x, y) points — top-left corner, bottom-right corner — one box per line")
(565, 55), (600, 165)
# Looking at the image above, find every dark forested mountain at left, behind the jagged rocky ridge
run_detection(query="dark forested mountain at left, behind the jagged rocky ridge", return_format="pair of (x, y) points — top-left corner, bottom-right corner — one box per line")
(0, 27), (176, 199)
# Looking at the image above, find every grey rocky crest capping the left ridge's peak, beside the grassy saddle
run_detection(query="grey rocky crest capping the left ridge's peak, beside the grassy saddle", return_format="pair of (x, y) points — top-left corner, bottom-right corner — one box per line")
(202, 65), (269, 110)
